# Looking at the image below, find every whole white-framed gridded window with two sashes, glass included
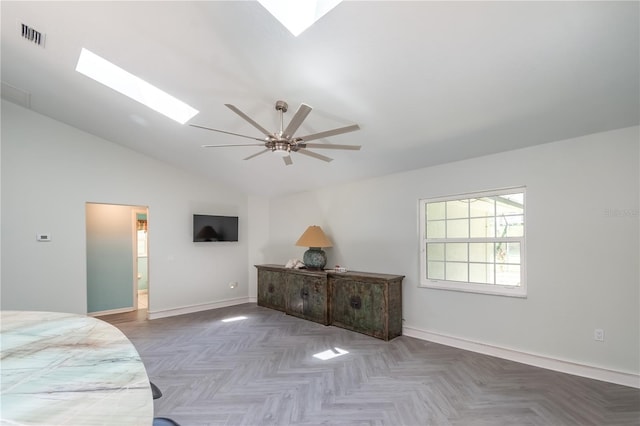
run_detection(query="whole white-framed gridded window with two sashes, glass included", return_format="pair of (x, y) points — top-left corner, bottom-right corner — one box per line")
(420, 188), (526, 297)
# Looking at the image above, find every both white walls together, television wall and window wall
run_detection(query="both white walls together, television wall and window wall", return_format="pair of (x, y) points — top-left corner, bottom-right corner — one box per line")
(0, 101), (640, 382)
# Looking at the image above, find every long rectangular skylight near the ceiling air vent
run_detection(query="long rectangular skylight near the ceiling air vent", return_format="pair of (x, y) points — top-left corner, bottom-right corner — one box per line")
(76, 48), (199, 124)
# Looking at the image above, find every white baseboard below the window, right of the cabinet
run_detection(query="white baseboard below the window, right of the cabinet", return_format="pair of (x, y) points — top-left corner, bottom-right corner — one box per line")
(402, 326), (640, 388)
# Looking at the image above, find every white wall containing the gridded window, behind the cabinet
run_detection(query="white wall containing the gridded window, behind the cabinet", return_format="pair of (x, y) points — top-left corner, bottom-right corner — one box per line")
(265, 127), (640, 374)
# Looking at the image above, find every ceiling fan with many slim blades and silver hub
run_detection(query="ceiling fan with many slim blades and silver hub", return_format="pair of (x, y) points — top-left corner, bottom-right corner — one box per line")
(190, 101), (360, 166)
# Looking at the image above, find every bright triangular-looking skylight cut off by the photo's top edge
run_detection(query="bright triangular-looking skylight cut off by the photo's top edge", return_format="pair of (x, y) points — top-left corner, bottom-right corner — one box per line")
(258, 0), (342, 37)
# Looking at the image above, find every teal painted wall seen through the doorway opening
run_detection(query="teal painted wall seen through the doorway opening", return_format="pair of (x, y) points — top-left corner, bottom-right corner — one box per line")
(86, 203), (134, 313)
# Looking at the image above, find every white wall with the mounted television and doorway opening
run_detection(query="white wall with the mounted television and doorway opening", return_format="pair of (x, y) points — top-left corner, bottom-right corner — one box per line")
(1, 101), (248, 314)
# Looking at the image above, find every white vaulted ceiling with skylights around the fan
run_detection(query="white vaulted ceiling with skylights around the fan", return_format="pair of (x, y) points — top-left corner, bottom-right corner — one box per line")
(0, 0), (640, 195)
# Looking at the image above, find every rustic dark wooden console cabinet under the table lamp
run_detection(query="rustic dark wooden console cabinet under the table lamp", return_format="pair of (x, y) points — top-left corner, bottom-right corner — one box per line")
(256, 265), (404, 340)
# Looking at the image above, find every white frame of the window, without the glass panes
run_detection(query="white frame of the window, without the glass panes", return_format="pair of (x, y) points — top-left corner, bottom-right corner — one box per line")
(418, 186), (527, 298)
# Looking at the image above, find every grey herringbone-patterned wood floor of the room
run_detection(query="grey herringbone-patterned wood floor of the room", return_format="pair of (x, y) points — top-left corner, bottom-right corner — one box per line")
(102, 304), (640, 426)
